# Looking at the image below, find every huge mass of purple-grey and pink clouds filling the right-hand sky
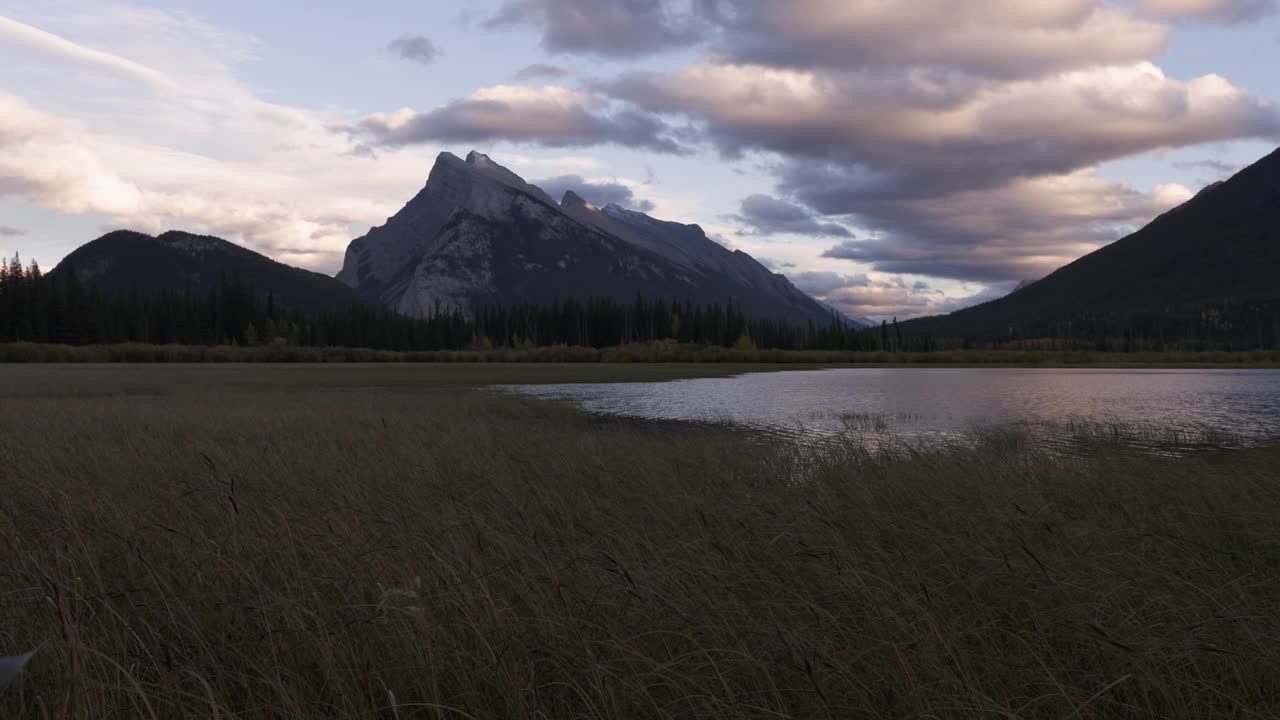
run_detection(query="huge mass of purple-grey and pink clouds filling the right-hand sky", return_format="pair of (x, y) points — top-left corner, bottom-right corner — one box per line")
(570, 0), (1280, 283)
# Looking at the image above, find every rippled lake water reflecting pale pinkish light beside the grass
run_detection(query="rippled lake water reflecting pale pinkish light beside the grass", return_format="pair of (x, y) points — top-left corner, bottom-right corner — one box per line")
(504, 368), (1280, 445)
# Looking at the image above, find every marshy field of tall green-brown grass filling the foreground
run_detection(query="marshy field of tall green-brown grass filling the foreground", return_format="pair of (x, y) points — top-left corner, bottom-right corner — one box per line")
(0, 365), (1280, 719)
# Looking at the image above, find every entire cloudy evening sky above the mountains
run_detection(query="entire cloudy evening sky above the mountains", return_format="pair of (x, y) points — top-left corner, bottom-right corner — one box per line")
(0, 0), (1280, 319)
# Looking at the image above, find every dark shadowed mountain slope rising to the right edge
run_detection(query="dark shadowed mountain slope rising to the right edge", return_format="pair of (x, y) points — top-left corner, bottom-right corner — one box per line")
(904, 150), (1280, 338)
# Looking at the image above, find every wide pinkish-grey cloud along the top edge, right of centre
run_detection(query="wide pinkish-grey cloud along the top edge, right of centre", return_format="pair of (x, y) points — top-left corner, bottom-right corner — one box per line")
(699, 0), (1167, 78)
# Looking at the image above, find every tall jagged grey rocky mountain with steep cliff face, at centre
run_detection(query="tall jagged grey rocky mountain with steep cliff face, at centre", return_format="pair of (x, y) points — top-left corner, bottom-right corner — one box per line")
(338, 152), (831, 323)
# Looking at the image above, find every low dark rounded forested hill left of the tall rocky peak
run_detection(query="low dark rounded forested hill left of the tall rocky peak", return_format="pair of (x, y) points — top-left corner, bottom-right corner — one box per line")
(50, 231), (358, 310)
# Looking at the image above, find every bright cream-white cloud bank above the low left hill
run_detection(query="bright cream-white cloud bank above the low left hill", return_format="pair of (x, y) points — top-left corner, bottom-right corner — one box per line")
(0, 5), (435, 272)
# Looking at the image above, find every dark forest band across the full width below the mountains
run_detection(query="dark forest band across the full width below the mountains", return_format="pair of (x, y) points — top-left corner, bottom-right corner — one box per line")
(0, 251), (1280, 352)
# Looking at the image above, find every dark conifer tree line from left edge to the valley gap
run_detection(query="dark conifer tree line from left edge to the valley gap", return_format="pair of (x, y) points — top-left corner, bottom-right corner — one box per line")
(0, 256), (932, 351)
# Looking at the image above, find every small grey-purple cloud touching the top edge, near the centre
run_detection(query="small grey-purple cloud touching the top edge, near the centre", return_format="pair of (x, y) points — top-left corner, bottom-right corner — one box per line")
(484, 0), (707, 58)
